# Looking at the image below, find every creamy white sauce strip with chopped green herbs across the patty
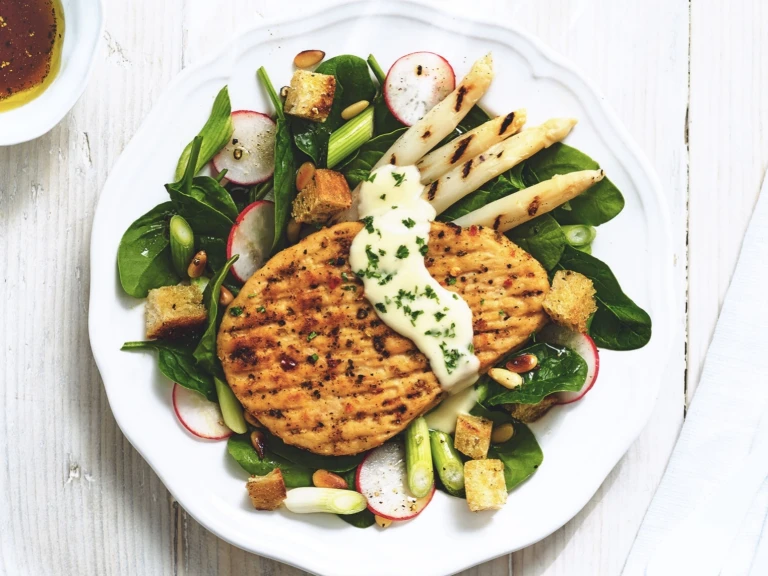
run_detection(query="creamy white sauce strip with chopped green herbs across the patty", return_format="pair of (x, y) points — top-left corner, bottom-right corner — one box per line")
(349, 165), (480, 393)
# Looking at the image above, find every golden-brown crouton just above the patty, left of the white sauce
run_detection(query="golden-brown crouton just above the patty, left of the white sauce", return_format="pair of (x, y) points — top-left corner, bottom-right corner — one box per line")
(293, 169), (352, 224)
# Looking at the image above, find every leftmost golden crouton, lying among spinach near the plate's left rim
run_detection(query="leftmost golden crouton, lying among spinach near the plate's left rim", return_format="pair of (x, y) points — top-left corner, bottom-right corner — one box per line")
(146, 285), (208, 340)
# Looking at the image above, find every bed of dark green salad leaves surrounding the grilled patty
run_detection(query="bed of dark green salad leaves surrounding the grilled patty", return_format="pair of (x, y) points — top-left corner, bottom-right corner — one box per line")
(117, 50), (651, 527)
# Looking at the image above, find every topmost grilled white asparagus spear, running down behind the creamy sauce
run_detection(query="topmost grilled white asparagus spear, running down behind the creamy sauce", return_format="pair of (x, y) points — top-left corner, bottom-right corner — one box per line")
(332, 52), (493, 223)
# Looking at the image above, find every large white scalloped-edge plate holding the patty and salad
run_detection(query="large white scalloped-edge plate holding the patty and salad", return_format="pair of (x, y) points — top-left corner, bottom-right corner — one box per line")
(90, 2), (675, 576)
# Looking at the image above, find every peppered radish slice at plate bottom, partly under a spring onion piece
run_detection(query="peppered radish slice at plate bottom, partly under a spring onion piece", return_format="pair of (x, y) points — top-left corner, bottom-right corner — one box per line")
(355, 441), (435, 520)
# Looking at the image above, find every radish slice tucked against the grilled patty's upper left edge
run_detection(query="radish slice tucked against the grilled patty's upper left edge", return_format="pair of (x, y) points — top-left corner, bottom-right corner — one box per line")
(227, 200), (275, 282)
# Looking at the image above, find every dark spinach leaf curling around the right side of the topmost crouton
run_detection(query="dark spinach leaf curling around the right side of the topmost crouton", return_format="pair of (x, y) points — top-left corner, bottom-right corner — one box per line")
(292, 55), (376, 166)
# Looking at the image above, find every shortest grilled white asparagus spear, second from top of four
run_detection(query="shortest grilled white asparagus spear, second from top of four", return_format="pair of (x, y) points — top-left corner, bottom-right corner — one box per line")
(416, 109), (527, 186)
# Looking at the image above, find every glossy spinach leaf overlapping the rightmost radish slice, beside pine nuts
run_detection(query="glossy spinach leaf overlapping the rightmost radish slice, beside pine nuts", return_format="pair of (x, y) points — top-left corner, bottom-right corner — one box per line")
(480, 342), (587, 406)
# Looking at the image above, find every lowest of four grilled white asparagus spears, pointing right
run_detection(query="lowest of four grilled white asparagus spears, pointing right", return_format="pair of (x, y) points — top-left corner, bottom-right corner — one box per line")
(453, 170), (604, 232)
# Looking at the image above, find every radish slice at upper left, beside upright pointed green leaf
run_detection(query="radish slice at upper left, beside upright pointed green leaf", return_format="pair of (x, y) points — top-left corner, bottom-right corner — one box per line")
(213, 110), (277, 186)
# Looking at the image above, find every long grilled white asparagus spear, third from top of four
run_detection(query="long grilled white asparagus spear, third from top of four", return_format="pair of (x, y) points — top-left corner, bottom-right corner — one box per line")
(423, 118), (576, 214)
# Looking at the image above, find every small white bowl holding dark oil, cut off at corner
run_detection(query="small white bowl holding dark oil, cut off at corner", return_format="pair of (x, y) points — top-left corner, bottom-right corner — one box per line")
(0, 0), (104, 146)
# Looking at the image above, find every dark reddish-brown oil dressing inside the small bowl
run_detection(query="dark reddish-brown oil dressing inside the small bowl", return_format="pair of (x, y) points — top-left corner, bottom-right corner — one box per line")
(0, 0), (64, 112)
